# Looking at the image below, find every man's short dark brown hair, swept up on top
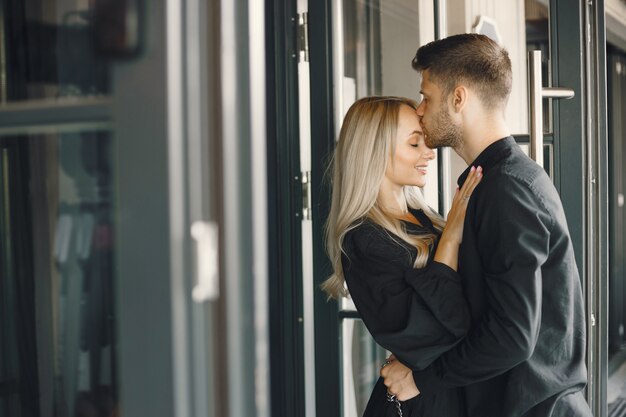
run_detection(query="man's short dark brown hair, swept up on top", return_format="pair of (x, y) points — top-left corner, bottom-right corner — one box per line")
(411, 33), (512, 109)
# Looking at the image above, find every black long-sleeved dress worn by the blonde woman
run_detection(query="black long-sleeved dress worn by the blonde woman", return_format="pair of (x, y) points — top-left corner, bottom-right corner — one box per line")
(342, 209), (470, 417)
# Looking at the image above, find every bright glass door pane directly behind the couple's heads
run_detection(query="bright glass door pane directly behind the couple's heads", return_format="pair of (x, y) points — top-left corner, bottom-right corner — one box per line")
(333, 0), (439, 210)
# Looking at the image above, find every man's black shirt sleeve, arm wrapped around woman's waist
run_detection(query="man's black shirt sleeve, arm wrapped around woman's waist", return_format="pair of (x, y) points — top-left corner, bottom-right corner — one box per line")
(413, 177), (552, 393)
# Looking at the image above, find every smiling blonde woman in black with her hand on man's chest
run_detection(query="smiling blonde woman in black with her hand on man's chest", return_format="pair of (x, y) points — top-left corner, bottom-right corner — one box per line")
(323, 97), (482, 417)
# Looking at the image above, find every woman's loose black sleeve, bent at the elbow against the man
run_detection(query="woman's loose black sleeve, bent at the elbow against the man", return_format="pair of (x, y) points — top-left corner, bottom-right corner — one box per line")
(343, 226), (470, 369)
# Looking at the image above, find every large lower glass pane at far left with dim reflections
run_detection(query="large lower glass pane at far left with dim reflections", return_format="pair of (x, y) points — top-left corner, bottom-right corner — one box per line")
(0, 132), (118, 417)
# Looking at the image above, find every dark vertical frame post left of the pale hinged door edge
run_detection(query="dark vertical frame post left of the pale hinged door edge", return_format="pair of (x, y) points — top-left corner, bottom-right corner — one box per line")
(265, 0), (305, 416)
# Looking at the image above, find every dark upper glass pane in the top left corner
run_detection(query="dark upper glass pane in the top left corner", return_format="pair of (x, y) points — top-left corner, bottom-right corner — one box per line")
(0, 0), (110, 103)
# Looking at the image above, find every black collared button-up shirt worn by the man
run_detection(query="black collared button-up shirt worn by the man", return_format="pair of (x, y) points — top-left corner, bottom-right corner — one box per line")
(413, 137), (591, 417)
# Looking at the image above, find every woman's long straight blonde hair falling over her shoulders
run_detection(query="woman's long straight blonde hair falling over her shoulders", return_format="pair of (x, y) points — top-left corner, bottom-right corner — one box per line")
(322, 96), (445, 299)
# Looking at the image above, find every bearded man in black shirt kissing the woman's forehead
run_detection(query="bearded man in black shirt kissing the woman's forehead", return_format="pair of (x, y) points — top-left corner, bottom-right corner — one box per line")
(381, 34), (591, 417)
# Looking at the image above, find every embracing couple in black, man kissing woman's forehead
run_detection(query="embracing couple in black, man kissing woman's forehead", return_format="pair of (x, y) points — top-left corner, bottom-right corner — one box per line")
(323, 34), (591, 417)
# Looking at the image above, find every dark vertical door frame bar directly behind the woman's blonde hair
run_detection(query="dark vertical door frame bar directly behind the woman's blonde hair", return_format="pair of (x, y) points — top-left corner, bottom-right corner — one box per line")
(309, 0), (342, 417)
